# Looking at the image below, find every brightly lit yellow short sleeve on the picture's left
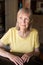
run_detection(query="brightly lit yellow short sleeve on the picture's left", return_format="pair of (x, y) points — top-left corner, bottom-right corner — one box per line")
(0, 29), (11, 45)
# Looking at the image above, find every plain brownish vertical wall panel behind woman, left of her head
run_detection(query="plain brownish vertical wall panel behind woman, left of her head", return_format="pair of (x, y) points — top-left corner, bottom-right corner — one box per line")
(5, 0), (18, 30)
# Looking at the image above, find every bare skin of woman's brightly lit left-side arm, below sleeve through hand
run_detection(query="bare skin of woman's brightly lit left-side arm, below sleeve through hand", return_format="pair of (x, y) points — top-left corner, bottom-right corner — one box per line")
(0, 43), (23, 65)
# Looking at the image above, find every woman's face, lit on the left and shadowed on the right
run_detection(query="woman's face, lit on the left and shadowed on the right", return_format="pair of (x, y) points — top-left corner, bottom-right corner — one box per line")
(17, 12), (30, 30)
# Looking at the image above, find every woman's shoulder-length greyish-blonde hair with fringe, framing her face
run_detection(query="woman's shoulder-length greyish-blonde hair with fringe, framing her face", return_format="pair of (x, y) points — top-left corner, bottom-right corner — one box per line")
(16, 8), (33, 30)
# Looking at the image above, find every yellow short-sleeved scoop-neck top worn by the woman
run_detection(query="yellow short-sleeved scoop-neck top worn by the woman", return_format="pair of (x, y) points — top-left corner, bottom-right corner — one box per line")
(0, 27), (39, 53)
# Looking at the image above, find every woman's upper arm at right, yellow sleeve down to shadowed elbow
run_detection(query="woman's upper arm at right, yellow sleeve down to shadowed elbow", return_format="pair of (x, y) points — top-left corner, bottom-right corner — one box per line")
(34, 31), (40, 56)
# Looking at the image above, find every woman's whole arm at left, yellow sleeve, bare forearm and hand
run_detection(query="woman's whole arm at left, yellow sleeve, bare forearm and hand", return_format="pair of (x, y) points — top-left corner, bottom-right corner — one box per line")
(0, 29), (23, 65)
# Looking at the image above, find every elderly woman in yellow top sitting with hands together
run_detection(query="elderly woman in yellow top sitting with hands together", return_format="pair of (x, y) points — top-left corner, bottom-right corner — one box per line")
(0, 8), (39, 65)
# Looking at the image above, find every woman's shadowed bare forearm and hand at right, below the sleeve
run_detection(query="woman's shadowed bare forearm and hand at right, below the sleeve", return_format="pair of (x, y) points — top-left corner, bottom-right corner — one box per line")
(21, 48), (40, 63)
